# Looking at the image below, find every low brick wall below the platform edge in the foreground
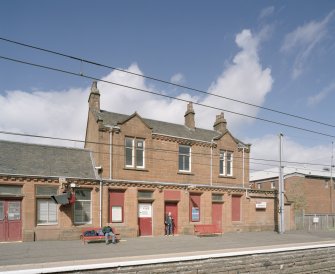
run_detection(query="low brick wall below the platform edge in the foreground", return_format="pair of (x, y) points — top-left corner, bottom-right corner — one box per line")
(67, 246), (335, 274)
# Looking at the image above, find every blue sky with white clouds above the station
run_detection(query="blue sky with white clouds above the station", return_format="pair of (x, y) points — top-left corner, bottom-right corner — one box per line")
(0, 0), (335, 172)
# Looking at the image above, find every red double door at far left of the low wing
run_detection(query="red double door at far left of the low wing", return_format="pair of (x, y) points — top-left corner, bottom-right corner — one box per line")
(0, 200), (22, 242)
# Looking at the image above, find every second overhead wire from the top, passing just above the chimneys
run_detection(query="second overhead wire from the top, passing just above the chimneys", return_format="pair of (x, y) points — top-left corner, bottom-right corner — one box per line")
(0, 56), (335, 138)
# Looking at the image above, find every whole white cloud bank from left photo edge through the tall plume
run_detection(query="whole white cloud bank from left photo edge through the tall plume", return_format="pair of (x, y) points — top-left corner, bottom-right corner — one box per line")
(0, 30), (273, 147)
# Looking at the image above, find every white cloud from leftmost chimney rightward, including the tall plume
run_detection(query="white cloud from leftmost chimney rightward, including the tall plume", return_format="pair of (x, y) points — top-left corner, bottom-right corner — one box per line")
(98, 30), (273, 133)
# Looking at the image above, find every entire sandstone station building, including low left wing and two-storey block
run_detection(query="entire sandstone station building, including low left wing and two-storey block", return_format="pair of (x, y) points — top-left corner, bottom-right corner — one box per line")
(0, 82), (277, 241)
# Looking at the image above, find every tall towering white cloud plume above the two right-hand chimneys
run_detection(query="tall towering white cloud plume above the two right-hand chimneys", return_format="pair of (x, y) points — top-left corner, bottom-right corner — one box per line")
(200, 30), (273, 130)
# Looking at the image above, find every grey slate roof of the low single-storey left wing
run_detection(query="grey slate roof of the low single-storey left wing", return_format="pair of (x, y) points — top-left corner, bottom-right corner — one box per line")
(0, 140), (95, 179)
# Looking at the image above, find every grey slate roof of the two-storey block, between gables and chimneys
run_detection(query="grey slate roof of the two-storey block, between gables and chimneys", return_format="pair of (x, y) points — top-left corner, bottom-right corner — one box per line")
(96, 110), (243, 144)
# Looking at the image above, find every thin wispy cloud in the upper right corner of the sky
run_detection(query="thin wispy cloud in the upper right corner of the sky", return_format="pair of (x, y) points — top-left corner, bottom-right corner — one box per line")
(281, 10), (335, 79)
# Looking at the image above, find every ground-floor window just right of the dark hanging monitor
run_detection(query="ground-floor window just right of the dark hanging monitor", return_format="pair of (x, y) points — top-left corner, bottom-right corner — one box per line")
(74, 189), (92, 224)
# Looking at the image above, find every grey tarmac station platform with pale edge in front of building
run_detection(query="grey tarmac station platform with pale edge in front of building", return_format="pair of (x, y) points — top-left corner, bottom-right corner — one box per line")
(0, 231), (335, 273)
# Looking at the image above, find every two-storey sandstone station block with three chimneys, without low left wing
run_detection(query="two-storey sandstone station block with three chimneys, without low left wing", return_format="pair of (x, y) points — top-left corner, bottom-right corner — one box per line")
(85, 82), (275, 236)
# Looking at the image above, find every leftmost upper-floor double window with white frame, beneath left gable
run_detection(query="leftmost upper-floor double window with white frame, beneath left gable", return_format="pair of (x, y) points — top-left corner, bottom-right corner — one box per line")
(125, 137), (145, 168)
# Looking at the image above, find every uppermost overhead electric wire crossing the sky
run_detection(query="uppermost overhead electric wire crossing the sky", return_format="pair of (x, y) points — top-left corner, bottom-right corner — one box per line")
(0, 37), (335, 127)
